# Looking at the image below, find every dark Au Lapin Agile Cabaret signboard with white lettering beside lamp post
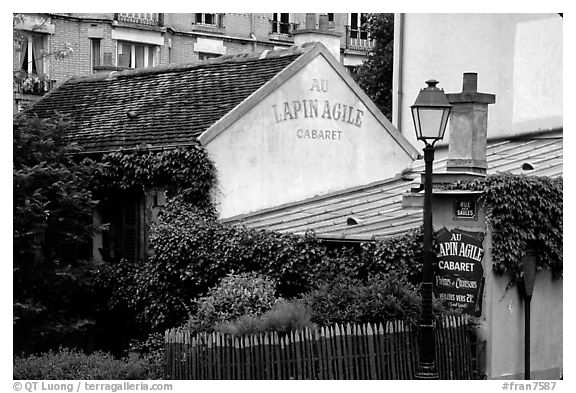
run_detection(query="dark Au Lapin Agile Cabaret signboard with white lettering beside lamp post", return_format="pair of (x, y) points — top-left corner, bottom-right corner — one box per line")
(435, 228), (484, 316)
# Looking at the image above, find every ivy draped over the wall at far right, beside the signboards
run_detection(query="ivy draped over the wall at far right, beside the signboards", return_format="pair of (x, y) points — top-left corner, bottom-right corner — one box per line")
(448, 174), (563, 288)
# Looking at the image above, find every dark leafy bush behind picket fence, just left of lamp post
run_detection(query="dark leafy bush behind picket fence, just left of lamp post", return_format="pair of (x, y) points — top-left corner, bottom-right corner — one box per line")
(303, 273), (421, 326)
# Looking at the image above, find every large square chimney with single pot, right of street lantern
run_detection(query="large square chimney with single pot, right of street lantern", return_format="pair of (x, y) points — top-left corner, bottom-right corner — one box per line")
(446, 72), (496, 175)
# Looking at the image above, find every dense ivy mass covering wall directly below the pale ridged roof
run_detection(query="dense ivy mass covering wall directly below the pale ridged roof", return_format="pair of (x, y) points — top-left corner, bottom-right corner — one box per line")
(100, 194), (422, 331)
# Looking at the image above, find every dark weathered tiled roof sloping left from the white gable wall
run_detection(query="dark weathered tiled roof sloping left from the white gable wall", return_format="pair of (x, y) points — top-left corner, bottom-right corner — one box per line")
(23, 46), (311, 151)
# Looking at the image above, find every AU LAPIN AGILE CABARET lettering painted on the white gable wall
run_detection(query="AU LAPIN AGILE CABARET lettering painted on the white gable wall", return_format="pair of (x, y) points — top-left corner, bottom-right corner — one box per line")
(272, 79), (364, 141)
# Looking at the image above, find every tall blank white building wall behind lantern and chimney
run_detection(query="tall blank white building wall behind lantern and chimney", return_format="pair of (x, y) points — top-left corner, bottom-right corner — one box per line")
(393, 14), (563, 147)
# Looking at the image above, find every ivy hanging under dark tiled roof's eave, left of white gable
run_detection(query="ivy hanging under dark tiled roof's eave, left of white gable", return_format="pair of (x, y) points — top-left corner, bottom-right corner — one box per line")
(93, 143), (216, 208)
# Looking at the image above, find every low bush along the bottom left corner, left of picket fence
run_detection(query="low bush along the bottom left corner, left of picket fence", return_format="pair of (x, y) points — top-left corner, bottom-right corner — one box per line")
(13, 348), (164, 380)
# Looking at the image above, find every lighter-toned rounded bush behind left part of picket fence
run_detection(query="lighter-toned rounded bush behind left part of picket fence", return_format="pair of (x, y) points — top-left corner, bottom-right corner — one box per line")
(190, 272), (278, 331)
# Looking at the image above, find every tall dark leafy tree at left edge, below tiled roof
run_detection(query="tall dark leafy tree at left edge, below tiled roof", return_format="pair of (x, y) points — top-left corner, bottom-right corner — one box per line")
(13, 116), (100, 352)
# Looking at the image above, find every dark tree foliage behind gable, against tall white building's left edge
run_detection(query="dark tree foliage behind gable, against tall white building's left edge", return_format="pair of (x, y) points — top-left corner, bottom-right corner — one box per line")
(354, 14), (394, 120)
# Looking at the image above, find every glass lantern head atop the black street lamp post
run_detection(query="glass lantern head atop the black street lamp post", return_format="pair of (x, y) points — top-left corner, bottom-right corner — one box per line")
(410, 79), (452, 145)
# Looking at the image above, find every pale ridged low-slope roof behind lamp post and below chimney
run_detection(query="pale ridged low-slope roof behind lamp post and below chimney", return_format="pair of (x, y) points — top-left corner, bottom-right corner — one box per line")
(222, 133), (563, 240)
